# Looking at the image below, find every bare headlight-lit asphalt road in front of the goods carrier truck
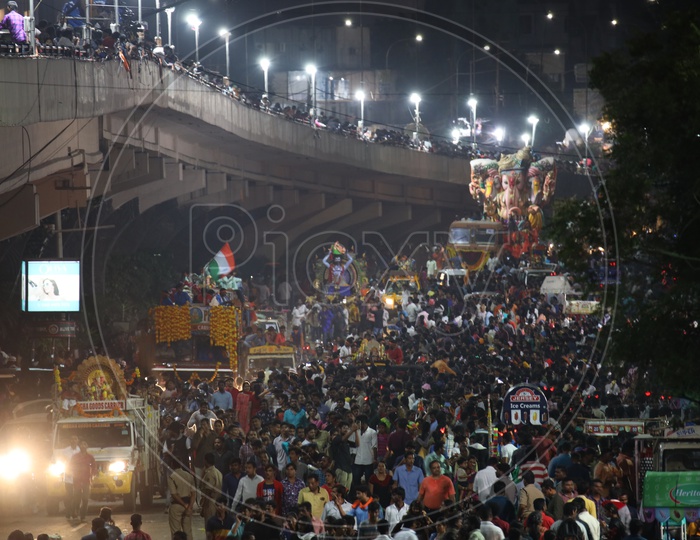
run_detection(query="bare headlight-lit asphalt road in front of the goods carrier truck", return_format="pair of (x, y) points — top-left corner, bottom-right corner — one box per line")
(0, 499), (206, 540)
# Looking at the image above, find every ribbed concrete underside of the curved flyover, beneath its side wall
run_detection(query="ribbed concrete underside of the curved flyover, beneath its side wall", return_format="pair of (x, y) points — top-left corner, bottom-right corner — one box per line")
(85, 109), (471, 260)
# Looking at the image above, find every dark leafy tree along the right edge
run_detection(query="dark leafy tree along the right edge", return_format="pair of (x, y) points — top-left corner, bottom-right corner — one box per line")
(550, 2), (700, 397)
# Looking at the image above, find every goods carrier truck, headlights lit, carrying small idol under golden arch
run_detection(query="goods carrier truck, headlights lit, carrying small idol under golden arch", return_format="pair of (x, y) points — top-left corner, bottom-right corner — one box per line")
(46, 357), (160, 515)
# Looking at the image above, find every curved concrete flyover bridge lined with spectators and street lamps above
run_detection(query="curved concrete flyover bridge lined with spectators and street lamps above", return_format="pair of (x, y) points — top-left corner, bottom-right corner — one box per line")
(0, 57), (475, 258)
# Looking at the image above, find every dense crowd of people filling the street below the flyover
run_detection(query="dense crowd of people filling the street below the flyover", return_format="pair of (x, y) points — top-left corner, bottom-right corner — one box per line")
(32, 249), (680, 540)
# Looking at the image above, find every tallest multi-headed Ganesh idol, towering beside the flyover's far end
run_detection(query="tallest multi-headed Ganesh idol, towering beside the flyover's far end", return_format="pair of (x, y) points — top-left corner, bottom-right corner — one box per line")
(469, 147), (557, 257)
